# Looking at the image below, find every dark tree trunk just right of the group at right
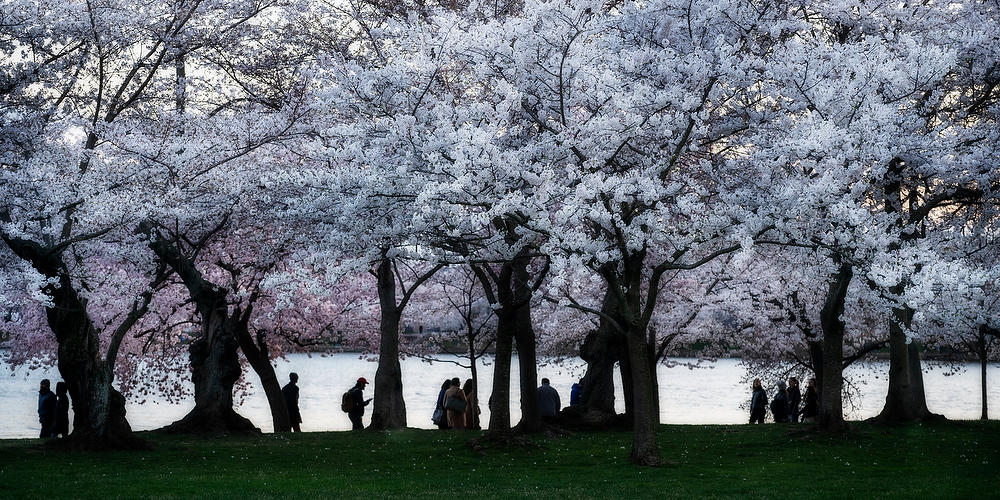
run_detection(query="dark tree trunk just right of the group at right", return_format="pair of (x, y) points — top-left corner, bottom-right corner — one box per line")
(819, 263), (854, 432)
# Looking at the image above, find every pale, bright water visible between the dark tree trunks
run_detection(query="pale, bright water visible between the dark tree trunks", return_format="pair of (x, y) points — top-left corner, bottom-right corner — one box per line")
(0, 353), (1000, 438)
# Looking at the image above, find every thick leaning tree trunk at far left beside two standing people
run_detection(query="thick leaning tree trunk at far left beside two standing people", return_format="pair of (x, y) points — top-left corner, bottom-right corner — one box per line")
(4, 237), (140, 449)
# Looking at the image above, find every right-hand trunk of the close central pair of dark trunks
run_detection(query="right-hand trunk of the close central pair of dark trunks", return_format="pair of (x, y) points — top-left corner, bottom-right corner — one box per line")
(511, 257), (542, 432)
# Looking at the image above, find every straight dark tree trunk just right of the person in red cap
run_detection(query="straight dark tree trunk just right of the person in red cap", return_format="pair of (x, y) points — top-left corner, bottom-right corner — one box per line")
(368, 256), (406, 430)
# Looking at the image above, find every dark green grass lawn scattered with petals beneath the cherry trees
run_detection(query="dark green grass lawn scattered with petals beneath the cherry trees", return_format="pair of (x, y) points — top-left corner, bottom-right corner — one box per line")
(0, 421), (1000, 500)
